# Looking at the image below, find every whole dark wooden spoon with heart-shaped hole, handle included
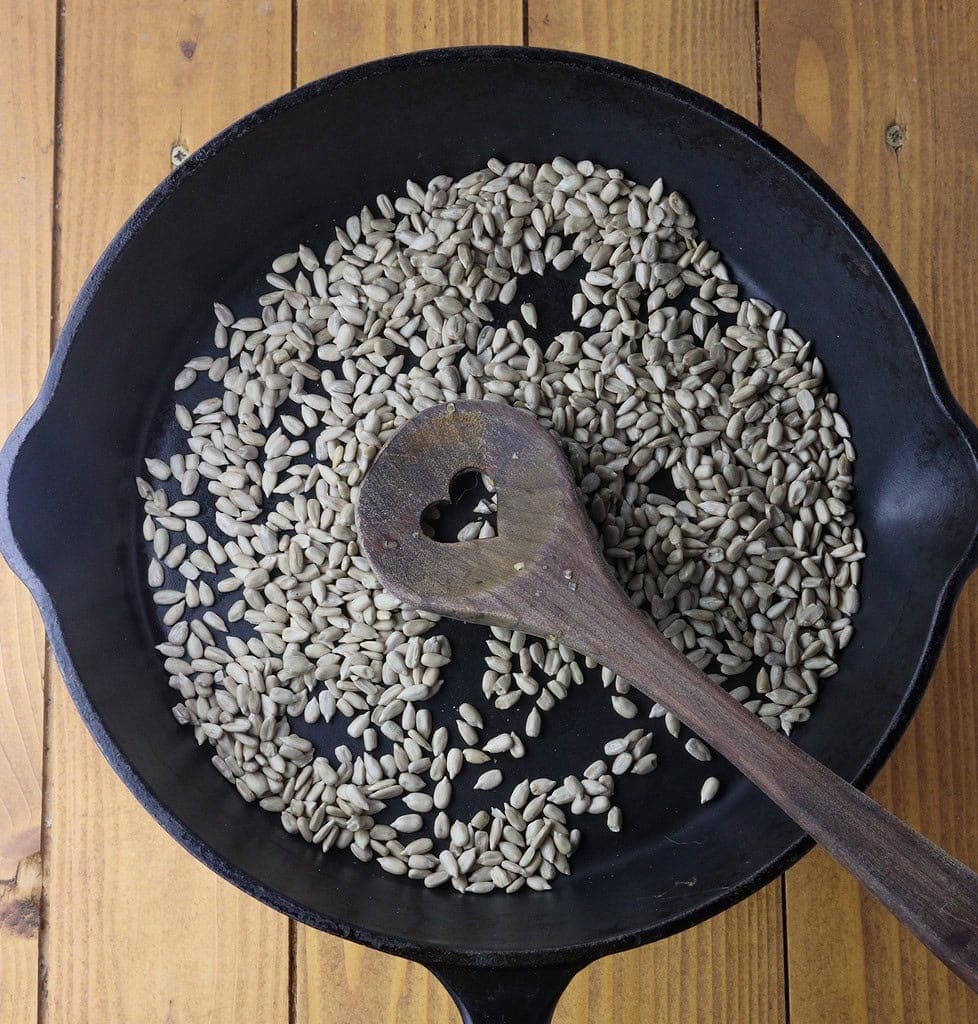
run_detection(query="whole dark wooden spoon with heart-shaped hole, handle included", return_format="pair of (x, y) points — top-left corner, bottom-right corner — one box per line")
(356, 401), (978, 991)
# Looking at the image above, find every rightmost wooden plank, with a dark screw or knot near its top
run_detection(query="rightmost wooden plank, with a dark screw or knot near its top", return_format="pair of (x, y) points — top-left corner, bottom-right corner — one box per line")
(760, 0), (978, 1024)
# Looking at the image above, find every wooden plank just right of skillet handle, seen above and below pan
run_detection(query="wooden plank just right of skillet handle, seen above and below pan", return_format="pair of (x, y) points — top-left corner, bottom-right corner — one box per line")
(527, 0), (784, 1024)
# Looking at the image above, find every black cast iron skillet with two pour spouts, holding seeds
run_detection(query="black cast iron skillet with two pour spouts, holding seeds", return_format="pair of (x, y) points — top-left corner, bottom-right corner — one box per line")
(0, 48), (978, 1024)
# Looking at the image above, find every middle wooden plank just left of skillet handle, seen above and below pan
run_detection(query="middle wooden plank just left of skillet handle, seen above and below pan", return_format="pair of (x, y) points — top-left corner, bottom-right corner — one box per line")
(295, 0), (523, 1024)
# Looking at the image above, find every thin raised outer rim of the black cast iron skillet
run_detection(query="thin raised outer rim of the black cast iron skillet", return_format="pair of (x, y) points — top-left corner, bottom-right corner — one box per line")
(0, 46), (978, 968)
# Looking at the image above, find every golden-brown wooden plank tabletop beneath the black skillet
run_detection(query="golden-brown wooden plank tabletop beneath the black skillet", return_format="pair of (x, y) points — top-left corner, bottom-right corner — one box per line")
(0, 0), (978, 1024)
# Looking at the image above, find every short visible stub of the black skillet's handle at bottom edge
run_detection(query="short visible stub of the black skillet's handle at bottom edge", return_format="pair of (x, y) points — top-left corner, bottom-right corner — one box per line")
(427, 963), (584, 1024)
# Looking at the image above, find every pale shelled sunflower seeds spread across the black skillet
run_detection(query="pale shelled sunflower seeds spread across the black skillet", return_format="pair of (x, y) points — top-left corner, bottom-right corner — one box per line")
(137, 158), (863, 893)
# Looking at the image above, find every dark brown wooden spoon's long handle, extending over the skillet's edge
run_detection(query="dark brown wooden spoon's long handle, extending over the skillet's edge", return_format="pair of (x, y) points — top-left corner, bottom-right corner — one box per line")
(566, 592), (978, 991)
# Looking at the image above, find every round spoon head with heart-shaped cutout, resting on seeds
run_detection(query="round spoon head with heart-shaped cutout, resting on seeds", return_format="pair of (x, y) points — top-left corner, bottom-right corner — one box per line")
(356, 401), (613, 635)
